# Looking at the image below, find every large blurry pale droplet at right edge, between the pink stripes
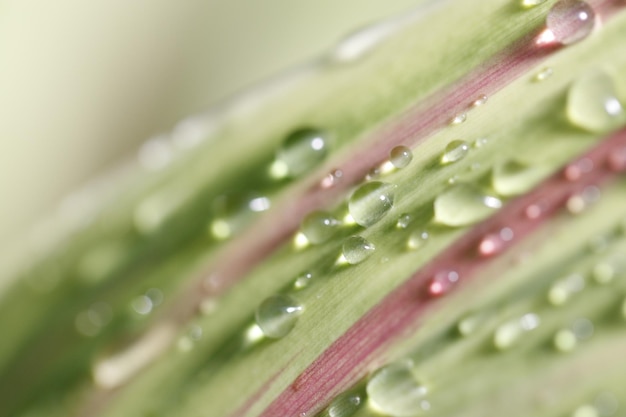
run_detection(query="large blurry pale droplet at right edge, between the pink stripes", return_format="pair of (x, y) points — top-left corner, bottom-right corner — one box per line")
(567, 71), (626, 133)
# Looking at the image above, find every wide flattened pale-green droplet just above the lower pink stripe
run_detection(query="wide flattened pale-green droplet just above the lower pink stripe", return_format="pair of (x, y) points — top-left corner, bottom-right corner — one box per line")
(435, 183), (502, 227)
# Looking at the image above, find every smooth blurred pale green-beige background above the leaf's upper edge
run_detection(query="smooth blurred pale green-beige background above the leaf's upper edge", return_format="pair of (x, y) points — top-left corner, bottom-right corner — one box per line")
(0, 0), (415, 250)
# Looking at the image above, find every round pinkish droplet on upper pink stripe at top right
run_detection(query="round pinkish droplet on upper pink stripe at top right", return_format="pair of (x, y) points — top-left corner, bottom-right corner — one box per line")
(546, 0), (596, 45)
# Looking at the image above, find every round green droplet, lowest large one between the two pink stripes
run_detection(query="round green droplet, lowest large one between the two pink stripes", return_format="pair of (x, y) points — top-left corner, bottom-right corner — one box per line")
(255, 294), (303, 339)
